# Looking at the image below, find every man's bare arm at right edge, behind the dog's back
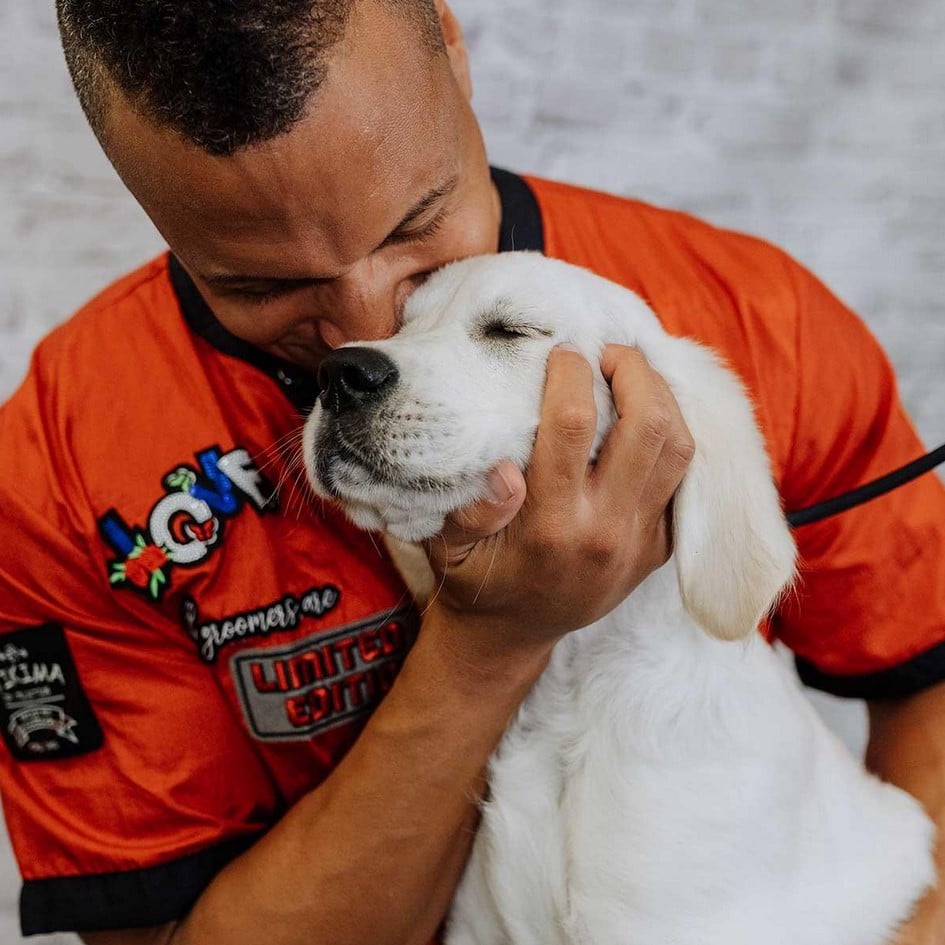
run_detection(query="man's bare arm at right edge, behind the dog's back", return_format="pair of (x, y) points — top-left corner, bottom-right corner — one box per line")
(866, 683), (945, 945)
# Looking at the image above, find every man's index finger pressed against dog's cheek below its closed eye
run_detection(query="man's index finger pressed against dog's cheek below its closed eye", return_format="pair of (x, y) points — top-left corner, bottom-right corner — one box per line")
(529, 347), (597, 505)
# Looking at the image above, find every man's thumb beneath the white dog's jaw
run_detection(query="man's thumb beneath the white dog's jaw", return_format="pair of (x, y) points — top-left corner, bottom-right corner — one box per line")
(427, 460), (525, 565)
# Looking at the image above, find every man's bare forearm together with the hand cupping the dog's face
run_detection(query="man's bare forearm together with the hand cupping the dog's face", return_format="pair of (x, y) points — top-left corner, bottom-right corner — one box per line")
(86, 347), (693, 945)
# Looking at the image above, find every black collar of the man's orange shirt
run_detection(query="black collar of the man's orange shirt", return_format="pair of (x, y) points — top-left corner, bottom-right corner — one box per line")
(170, 167), (545, 411)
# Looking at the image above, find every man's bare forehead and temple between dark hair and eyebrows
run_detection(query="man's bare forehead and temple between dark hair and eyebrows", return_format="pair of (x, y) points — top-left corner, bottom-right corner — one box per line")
(102, 5), (461, 271)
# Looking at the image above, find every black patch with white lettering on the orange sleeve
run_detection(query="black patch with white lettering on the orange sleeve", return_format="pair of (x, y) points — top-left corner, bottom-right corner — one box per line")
(0, 623), (103, 761)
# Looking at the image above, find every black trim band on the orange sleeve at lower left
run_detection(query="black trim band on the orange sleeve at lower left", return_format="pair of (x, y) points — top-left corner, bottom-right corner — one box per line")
(20, 836), (257, 935)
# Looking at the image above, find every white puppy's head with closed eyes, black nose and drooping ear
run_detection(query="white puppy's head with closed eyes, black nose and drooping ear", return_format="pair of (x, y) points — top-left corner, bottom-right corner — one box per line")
(303, 253), (793, 638)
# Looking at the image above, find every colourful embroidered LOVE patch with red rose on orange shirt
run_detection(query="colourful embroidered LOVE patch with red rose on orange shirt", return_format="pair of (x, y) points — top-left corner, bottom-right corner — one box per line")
(98, 446), (276, 601)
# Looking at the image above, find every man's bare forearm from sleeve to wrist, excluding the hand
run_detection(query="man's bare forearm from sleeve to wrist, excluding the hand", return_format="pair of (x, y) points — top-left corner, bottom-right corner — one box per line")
(172, 604), (547, 945)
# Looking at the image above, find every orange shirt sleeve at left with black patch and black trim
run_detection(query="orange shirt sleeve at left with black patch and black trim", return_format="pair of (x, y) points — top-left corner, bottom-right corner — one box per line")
(0, 366), (280, 935)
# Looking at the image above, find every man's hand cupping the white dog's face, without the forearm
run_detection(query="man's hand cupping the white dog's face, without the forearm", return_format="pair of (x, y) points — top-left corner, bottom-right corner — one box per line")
(420, 345), (694, 652)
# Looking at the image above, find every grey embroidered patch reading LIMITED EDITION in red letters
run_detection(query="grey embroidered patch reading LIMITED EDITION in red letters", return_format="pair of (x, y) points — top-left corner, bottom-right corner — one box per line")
(230, 607), (419, 741)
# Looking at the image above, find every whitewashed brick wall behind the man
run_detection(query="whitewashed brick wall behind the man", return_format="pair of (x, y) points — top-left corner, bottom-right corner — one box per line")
(0, 0), (945, 945)
